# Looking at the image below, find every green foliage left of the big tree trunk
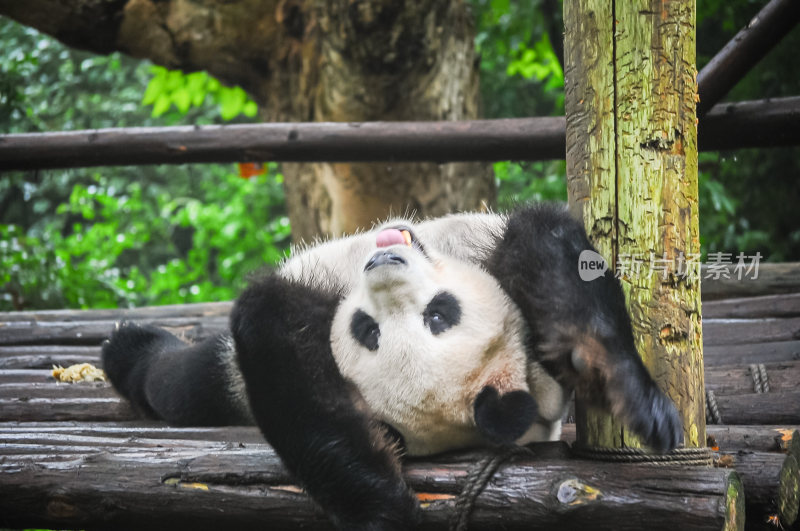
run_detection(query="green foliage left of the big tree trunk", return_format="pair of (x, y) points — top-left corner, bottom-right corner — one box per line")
(0, 18), (289, 310)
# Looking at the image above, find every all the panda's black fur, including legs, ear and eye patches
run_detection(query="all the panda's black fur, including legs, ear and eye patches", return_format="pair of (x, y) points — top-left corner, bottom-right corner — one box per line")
(103, 206), (681, 530)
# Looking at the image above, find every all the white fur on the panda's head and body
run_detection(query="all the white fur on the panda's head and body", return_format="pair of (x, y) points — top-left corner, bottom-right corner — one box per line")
(279, 214), (565, 455)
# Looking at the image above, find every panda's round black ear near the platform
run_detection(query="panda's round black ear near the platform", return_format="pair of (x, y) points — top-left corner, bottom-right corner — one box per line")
(474, 385), (539, 444)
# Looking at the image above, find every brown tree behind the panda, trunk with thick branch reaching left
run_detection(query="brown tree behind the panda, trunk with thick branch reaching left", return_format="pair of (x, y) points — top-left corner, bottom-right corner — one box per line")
(0, 0), (495, 239)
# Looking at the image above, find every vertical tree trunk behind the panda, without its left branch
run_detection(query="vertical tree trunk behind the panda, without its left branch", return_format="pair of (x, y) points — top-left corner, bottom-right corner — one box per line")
(284, 0), (494, 238)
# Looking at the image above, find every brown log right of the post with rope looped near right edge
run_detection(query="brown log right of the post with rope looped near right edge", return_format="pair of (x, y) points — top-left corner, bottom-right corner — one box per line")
(705, 361), (800, 396)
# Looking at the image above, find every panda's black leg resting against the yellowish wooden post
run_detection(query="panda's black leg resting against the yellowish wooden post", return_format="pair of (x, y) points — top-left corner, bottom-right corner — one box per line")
(486, 204), (682, 451)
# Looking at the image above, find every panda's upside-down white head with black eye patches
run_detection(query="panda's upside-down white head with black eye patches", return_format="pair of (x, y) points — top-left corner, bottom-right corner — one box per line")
(332, 226), (529, 455)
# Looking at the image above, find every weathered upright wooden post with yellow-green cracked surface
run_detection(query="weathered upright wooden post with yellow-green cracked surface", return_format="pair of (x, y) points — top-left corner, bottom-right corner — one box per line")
(564, 0), (705, 454)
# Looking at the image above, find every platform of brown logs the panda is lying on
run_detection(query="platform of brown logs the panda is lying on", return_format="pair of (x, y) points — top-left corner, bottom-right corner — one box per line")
(0, 264), (800, 529)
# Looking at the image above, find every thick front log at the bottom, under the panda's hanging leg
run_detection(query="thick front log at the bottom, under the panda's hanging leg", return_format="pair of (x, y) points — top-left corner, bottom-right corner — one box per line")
(0, 439), (744, 530)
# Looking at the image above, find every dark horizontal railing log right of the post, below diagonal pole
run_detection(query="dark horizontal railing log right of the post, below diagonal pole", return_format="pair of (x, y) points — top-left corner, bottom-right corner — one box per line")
(697, 93), (800, 151)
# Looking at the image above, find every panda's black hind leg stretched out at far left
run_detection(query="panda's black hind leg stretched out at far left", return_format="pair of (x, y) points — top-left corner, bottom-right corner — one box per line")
(103, 322), (251, 426)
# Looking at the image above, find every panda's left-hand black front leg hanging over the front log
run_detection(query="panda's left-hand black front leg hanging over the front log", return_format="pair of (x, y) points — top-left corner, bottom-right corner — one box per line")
(231, 275), (419, 530)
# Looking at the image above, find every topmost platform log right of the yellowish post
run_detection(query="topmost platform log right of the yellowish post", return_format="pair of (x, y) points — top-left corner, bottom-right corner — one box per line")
(701, 262), (800, 300)
